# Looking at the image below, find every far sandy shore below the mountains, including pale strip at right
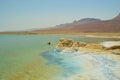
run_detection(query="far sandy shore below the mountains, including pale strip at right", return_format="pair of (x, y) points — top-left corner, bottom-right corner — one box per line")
(0, 32), (120, 40)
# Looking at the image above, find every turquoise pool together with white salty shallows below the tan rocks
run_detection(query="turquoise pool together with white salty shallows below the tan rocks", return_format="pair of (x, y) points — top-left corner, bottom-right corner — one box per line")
(41, 51), (120, 80)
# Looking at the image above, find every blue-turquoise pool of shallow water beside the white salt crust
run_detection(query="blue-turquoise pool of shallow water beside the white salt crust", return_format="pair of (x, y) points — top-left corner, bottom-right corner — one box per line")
(41, 50), (82, 77)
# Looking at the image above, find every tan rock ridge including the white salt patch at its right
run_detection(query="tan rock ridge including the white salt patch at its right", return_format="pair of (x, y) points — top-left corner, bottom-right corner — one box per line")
(56, 39), (120, 55)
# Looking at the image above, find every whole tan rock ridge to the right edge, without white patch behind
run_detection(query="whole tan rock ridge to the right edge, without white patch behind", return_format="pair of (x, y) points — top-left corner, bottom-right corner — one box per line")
(56, 39), (120, 53)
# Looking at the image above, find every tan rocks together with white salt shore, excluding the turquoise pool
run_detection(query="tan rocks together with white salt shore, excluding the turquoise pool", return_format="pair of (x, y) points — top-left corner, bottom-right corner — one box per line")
(56, 39), (120, 80)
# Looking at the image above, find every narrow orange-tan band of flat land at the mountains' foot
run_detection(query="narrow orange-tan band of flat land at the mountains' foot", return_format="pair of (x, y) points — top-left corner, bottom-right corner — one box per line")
(0, 31), (120, 37)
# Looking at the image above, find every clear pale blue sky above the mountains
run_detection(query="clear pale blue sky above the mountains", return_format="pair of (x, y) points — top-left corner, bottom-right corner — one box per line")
(0, 0), (120, 31)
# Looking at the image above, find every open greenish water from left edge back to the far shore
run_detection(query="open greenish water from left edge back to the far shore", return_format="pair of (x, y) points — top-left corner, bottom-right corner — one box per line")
(0, 34), (118, 80)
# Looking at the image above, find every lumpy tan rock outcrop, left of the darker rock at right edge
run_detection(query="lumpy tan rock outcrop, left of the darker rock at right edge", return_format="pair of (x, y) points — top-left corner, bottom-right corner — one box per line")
(56, 39), (103, 49)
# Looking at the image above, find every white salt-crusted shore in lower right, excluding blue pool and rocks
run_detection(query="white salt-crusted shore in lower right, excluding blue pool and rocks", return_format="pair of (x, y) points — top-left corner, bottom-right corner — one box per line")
(58, 52), (120, 80)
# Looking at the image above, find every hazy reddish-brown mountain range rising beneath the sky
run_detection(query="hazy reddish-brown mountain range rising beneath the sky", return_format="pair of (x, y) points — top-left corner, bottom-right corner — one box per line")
(32, 14), (120, 33)
